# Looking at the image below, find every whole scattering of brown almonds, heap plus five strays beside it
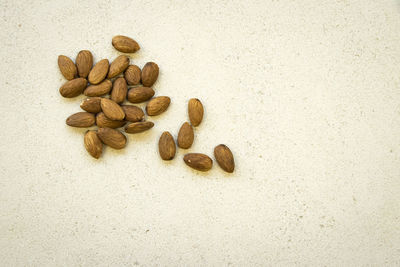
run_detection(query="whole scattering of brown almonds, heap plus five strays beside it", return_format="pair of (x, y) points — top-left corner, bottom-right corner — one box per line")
(58, 35), (235, 173)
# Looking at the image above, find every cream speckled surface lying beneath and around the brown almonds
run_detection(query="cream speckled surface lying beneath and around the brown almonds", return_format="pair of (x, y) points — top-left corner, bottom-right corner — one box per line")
(0, 0), (400, 266)
